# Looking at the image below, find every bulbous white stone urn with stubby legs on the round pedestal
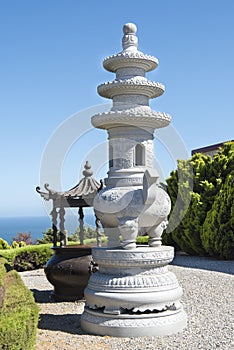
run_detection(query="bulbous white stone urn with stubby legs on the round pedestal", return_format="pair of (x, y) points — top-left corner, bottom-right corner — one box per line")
(94, 169), (171, 249)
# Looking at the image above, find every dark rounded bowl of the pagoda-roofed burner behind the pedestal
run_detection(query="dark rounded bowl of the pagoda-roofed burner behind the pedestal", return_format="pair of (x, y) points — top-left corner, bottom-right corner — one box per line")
(44, 245), (96, 301)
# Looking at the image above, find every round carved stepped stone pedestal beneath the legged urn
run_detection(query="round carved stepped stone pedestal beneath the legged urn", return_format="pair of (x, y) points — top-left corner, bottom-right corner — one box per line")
(81, 246), (187, 337)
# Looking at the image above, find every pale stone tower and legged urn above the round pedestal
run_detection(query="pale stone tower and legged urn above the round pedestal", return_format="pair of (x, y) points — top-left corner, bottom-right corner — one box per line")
(92, 23), (170, 249)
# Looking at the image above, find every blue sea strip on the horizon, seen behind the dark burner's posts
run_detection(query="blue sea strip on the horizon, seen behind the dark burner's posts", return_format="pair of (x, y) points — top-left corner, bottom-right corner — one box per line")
(0, 214), (95, 244)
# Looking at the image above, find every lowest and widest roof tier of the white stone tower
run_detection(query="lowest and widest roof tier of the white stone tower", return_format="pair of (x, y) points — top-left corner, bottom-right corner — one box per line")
(92, 106), (171, 130)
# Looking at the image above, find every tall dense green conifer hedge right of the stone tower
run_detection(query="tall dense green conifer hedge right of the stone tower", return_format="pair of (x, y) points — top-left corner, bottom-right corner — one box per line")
(163, 142), (234, 258)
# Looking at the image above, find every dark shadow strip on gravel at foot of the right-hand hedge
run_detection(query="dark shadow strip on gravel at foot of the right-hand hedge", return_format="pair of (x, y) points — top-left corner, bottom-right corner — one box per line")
(171, 255), (234, 275)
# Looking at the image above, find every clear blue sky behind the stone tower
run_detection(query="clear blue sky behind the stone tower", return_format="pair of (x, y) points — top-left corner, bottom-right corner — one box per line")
(0, 0), (234, 216)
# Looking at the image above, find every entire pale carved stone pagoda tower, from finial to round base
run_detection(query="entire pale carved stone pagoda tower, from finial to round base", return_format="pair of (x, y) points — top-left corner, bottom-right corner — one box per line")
(81, 23), (187, 337)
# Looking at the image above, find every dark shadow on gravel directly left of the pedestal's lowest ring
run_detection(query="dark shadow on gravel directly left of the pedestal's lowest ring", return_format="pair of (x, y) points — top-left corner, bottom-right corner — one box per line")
(38, 314), (86, 335)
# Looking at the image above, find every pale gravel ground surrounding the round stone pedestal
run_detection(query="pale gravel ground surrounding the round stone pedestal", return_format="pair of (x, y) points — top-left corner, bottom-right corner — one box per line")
(20, 256), (234, 350)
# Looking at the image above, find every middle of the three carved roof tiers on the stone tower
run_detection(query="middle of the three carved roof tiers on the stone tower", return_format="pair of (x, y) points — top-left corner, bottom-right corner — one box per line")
(98, 76), (165, 99)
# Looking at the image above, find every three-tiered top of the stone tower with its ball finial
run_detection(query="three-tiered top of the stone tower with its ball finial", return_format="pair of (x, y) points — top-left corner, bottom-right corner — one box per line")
(92, 23), (171, 132)
